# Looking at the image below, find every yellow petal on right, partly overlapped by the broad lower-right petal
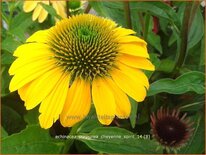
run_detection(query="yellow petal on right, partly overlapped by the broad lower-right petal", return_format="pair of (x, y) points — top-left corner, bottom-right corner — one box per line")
(116, 62), (149, 89)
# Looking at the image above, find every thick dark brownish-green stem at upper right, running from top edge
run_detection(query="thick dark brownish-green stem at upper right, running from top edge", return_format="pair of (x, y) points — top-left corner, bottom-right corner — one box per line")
(173, 2), (192, 75)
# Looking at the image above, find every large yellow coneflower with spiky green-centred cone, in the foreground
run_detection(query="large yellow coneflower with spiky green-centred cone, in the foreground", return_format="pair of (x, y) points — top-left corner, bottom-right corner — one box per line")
(9, 14), (154, 128)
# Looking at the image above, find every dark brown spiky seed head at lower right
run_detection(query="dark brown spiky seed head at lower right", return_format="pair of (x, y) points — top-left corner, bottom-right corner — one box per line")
(151, 107), (193, 149)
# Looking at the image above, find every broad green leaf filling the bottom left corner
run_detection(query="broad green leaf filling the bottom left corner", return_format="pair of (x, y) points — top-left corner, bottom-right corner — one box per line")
(1, 125), (64, 154)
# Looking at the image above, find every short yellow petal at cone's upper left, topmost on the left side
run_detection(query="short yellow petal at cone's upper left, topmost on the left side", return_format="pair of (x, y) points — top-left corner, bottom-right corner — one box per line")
(26, 28), (52, 43)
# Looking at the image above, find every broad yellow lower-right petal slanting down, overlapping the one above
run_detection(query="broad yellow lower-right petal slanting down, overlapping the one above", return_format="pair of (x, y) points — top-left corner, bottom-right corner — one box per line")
(111, 69), (146, 102)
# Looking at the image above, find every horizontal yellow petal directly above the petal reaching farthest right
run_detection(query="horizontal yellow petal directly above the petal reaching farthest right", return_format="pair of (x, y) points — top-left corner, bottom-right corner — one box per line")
(118, 44), (149, 58)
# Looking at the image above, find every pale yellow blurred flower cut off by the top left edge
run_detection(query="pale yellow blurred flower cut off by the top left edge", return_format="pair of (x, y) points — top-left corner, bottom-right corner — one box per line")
(23, 0), (67, 23)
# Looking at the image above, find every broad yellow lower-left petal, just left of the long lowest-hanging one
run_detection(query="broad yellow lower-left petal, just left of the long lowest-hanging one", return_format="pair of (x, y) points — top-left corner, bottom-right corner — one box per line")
(24, 68), (63, 110)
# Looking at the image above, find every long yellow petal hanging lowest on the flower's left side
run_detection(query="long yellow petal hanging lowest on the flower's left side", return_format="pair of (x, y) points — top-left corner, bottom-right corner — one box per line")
(39, 74), (70, 129)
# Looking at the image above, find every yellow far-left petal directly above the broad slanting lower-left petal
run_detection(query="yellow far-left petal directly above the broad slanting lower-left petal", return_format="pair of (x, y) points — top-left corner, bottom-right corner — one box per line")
(9, 60), (54, 92)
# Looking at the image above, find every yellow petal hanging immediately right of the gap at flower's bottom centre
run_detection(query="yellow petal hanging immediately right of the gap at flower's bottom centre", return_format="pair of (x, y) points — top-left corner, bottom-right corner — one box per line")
(92, 78), (116, 125)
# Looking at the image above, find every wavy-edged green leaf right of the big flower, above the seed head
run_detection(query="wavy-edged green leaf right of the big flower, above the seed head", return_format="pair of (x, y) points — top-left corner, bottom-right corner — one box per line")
(148, 71), (205, 96)
